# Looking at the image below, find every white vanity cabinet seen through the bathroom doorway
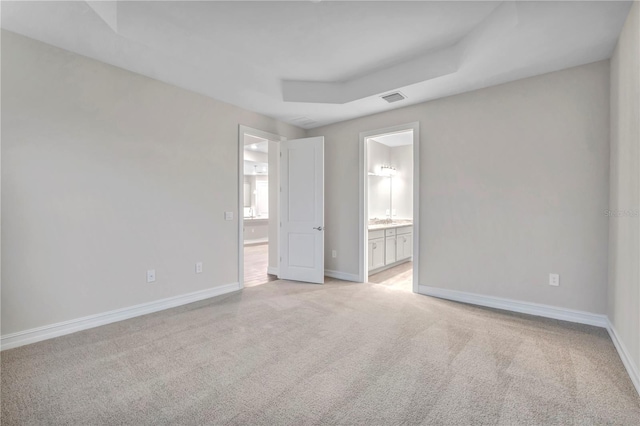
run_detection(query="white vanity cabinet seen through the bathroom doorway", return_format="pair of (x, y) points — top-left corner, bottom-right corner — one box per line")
(367, 225), (413, 275)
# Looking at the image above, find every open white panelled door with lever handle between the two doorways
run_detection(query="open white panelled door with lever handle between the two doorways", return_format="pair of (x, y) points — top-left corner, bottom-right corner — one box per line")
(278, 136), (324, 284)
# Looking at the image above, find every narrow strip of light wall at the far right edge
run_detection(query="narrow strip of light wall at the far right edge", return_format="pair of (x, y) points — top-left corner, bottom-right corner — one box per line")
(608, 2), (640, 380)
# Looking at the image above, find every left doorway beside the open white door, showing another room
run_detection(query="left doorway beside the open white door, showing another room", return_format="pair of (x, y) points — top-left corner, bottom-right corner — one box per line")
(238, 125), (285, 287)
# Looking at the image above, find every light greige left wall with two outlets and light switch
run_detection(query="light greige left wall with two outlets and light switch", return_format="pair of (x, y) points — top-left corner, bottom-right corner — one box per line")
(2, 31), (305, 335)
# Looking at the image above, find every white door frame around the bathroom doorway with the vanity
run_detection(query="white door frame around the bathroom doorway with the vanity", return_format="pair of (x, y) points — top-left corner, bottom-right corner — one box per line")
(358, 121), (420, 293)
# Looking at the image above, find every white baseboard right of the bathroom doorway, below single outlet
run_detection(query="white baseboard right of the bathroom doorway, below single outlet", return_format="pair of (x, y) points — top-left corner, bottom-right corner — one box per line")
(418, 285), (608, 328)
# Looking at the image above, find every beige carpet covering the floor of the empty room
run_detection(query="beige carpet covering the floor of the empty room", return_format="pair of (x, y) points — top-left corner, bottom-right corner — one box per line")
(2, 281), (640, 425)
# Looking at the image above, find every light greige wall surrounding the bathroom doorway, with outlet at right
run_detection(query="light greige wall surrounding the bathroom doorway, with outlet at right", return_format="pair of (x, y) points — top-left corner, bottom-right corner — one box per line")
(308, 61), (609, 314)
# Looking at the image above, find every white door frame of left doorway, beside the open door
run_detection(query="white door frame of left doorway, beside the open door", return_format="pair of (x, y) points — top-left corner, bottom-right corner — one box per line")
(238, 124), (287, 288)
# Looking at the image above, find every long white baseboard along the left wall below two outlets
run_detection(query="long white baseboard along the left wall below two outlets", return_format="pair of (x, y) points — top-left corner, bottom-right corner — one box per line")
(0, 283), (241, 350)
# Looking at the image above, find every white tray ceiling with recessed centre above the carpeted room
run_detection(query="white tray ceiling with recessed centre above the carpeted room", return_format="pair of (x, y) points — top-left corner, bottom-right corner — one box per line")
(1, 1), (630, 128)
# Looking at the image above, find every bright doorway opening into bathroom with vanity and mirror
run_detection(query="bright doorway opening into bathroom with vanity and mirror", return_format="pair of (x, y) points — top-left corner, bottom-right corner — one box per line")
(360, 123), (420, 293)
